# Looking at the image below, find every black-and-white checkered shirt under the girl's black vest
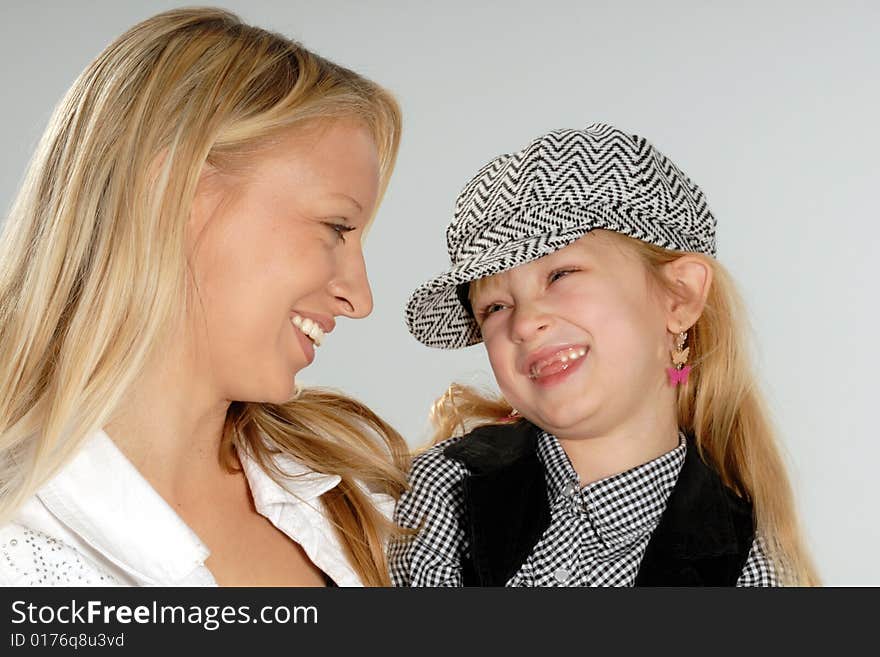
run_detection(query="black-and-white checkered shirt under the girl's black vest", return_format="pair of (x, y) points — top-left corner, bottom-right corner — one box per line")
(389, 431), (779, 586)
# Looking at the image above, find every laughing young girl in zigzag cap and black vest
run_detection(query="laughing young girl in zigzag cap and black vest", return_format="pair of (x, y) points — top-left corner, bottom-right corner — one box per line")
(391, 124), (817, 586)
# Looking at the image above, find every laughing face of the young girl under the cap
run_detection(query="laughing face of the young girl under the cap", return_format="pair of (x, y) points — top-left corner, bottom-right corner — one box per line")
(472, 230), (674, 439)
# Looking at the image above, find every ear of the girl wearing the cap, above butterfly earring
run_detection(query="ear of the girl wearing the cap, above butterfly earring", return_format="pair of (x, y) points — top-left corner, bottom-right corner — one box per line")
(663, 254), (712, 333)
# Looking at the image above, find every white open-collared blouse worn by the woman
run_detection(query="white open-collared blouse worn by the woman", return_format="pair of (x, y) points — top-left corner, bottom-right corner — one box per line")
(0, 431), (394, 586)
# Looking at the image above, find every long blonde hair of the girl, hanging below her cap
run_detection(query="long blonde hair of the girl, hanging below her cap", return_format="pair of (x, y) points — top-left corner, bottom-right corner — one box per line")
(431, 232), (818, 586)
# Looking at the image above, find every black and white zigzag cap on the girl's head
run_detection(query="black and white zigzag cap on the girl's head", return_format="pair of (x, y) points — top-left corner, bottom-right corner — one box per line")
(406, 123), (715, 349)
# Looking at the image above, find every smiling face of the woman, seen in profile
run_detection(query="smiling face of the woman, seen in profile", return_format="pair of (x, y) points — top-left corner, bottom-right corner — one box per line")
(188, 121), (379, 403)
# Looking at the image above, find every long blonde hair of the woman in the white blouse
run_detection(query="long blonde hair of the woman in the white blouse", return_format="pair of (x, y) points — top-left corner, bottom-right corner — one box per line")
(0, 8), (406, 585)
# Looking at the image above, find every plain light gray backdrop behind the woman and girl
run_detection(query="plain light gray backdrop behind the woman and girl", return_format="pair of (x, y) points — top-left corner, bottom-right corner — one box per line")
(0, 0), (880, 585)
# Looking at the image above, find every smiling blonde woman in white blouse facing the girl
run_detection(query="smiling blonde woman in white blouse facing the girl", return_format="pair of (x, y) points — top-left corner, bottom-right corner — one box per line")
(0, 9), (406, 585)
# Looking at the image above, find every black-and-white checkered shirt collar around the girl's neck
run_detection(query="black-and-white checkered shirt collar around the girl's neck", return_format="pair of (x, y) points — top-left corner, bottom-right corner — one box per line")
(538, 431), (687, 548)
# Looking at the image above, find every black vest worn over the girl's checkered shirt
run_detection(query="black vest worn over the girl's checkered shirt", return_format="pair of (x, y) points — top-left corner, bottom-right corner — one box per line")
(444, 421), (754, 586)
